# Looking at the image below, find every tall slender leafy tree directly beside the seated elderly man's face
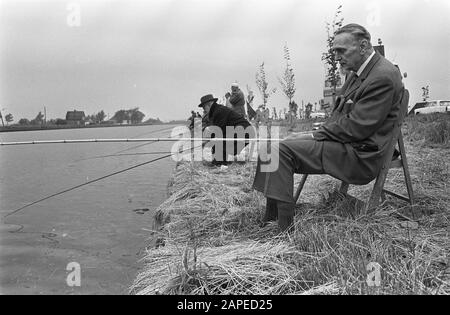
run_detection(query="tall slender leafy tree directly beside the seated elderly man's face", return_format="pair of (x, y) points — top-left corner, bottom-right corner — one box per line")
(322, 5), (344, 107)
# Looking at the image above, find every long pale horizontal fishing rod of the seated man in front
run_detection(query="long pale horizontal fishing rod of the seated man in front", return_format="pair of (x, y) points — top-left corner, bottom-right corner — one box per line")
(0, 138), (284, 146)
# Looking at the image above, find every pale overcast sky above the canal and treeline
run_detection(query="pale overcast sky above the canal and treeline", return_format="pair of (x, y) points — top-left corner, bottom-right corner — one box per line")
(0, 0), (450, 122)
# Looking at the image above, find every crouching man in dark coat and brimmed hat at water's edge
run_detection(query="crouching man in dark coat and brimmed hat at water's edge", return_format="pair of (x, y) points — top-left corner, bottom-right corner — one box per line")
(199, 94), (254, 166)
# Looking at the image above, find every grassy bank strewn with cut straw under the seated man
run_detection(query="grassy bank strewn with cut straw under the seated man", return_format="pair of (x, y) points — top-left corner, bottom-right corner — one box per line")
(131, 115), (450, 294)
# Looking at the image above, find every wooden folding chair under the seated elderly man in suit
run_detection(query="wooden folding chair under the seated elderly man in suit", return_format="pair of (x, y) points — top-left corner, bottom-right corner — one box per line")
(294, 89), (414, 214)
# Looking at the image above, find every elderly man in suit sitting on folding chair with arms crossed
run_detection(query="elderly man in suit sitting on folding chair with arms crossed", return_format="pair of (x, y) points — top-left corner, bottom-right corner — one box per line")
(253, 24), (404, 231)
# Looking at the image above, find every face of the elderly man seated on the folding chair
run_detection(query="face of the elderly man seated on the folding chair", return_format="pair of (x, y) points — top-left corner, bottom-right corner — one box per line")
(332, 33), (364, 72)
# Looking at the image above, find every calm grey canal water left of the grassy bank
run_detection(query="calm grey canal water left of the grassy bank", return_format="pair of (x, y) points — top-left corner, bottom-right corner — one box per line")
(0, 126), (179, 294)
